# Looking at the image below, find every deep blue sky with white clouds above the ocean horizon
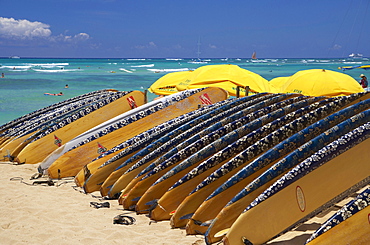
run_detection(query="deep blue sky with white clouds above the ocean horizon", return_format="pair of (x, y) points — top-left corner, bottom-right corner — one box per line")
(0, 0), (370, 58)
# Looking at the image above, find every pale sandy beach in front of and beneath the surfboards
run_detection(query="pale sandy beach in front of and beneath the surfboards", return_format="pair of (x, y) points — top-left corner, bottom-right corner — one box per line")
(0, 162), (368, 245)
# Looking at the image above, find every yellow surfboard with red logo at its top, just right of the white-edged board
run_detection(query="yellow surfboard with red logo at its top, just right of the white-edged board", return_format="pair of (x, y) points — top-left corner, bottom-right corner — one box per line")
(48, 88), (228, 178)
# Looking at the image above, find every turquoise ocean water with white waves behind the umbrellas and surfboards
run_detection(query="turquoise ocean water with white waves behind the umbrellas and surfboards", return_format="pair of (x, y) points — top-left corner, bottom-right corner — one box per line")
(0, 58), (370, 125)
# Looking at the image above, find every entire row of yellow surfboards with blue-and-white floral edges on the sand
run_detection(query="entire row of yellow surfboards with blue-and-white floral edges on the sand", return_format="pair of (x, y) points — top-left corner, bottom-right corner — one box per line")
(0, 88), (370, 245)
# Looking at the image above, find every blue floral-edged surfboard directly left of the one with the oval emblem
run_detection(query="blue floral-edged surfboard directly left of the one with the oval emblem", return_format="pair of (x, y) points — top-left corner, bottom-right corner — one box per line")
(205, 108), (370, 242)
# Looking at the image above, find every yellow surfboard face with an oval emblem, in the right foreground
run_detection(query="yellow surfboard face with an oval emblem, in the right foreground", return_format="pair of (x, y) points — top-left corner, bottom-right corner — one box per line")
(224, 139), (370, 245)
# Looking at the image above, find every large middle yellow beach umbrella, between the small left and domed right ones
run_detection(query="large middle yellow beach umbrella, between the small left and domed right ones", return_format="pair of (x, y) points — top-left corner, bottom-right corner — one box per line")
(176, 65), (271, 96)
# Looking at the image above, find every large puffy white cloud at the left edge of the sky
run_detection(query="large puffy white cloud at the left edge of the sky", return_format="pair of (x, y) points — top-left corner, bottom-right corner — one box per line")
(0, 17), (51, 39)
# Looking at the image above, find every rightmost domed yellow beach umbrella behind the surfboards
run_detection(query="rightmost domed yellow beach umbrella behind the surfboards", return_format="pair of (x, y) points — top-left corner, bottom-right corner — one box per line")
(281, 69), (364, 96)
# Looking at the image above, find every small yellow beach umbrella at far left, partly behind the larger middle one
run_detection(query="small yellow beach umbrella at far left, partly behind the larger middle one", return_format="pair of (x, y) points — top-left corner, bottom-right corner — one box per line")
(148, 71), (192, 95)
